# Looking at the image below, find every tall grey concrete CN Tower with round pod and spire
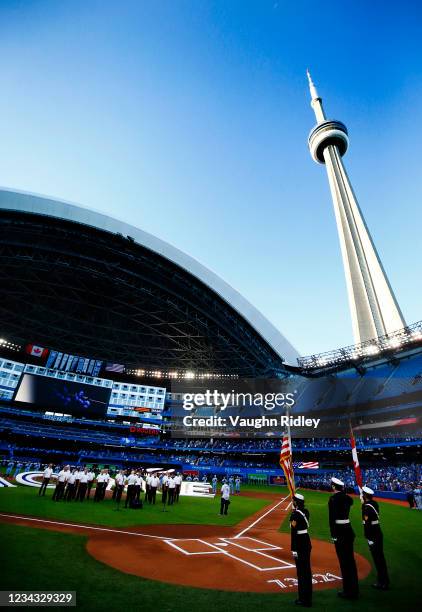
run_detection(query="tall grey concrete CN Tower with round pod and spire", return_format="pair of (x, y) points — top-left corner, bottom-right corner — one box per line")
(307, 71), (406, 344)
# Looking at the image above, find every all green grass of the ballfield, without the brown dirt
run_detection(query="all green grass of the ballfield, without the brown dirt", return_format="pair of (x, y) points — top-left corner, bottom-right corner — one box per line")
(0, 486), (422, 612)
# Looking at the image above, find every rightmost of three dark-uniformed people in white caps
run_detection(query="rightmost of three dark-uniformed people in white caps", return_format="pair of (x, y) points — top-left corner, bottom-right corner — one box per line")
(362, 487), (390, 591)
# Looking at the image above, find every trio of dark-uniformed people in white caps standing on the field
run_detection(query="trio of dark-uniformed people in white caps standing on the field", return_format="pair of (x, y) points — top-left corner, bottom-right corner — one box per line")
(290, 478), (390, 607)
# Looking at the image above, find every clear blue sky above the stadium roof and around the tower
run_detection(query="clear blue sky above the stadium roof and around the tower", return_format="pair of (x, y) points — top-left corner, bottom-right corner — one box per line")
(0, 0), (422, 354)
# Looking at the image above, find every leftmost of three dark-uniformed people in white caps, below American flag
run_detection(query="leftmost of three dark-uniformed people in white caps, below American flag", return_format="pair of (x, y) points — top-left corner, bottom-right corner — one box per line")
(290, 493), (312, 608)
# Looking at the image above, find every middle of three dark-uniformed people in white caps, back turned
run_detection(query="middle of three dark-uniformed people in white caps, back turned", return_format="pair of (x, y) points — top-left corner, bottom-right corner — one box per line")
(328, 478), (359, 599)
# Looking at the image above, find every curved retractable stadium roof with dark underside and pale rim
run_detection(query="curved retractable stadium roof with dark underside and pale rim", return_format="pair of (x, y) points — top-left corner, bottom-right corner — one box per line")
(0, 189), (298, 376)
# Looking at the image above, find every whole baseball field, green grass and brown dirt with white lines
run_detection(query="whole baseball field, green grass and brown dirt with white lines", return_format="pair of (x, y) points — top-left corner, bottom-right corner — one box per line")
(0, 486), (422, 612)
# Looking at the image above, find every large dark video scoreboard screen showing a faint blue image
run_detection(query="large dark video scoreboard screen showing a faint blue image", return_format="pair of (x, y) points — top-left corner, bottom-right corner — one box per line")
(15, 374), (111, 417)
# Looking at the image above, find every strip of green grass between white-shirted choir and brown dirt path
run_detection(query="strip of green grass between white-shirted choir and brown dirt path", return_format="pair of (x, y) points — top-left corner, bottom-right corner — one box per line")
(0, 486), (268, 527)
